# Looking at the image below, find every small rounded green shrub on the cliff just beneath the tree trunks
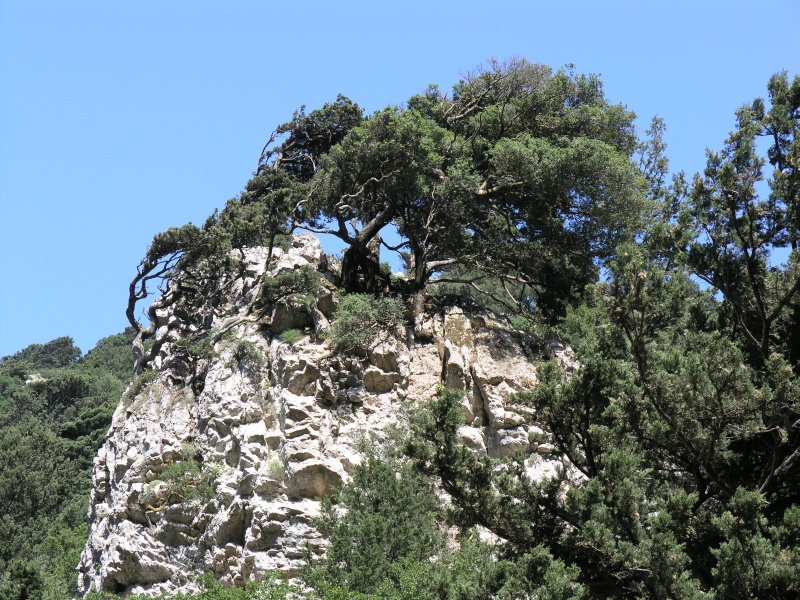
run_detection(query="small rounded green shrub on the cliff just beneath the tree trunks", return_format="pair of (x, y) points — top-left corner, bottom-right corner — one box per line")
(329, 294), (405, 352)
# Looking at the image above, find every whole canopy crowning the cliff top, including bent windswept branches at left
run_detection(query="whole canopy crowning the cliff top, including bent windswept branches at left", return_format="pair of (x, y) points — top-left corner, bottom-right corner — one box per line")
(127, 59), (648, 370)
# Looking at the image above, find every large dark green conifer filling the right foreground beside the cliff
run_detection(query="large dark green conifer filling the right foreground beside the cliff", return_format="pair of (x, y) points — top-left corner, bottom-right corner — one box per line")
(408, 84), (800, 598)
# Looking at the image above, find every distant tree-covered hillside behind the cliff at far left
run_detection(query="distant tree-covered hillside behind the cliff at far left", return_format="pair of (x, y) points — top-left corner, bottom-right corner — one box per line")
(0, 331), (133, 600)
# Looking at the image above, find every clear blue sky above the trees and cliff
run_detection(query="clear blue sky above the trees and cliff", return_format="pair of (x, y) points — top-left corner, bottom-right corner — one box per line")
(0, 0), (800, 356)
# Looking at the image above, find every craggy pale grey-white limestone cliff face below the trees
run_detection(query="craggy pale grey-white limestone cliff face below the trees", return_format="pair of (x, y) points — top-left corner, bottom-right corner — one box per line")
(79, 235), (572, 596)
